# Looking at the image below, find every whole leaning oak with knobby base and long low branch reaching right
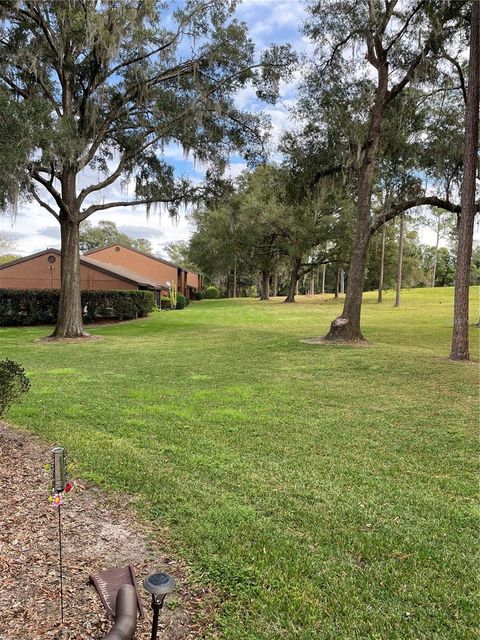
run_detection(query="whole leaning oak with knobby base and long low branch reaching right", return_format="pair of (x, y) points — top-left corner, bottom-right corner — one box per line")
(304, 0), (467, 341)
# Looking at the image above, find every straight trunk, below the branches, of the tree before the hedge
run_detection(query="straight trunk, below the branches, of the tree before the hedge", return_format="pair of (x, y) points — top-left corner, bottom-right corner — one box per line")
(51, 216), (88, 338)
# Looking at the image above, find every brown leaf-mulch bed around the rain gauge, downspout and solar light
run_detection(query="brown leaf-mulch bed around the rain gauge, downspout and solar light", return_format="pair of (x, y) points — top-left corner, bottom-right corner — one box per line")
(0, 423), (213, 640)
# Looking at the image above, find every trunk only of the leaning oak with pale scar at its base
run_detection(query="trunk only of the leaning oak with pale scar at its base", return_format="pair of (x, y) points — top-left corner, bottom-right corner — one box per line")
(325, 68), (388, 342)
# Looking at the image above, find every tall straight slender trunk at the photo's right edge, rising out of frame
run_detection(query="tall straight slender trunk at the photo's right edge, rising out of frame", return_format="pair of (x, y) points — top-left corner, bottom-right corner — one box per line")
(450, 2), (480, 360)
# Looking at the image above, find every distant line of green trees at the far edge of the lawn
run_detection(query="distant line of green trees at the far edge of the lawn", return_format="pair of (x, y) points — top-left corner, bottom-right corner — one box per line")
(182, 165), (480, 302)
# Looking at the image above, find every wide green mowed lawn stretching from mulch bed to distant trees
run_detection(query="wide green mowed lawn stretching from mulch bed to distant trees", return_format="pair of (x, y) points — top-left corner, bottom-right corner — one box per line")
(0, 288), (479, 640)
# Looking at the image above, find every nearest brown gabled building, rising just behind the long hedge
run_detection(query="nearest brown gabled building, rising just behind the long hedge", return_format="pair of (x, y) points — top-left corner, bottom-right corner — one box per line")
(0, 249), (168, 305)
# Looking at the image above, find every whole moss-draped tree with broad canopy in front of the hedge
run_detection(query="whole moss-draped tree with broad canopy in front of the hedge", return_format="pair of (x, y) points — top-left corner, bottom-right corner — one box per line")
(0, 0), (290, 337)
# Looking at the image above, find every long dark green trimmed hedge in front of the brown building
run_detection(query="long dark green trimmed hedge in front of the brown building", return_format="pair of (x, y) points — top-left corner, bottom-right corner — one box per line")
(0, 289), (154, 326)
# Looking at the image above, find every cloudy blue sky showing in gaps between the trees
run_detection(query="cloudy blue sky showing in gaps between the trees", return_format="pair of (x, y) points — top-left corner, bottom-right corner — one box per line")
(0, 0), (308, 255)
